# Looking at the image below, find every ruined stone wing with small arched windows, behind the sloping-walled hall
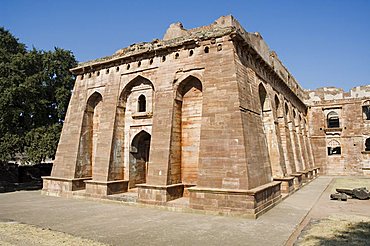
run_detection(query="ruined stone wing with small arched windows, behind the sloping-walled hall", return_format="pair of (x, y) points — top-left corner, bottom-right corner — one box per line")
(305, 86), (370, 175)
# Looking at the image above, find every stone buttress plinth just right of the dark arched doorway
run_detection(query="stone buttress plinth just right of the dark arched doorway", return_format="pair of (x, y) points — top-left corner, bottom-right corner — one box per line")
(136, 184), (184, 205)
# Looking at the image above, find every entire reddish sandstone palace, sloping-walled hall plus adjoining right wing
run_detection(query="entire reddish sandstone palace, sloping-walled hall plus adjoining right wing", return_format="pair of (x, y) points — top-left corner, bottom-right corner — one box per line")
(43, 16), (370, 217)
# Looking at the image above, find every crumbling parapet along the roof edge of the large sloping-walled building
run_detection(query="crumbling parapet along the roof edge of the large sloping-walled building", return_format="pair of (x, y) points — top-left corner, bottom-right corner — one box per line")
(71, 15), (305, 104)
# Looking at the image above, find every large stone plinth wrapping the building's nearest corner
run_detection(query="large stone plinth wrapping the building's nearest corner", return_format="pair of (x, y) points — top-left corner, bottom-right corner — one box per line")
(188, 181), (281, 218)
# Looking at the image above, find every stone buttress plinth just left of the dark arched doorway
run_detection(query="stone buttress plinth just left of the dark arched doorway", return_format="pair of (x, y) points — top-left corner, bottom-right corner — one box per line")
(85, 180), (128, 197)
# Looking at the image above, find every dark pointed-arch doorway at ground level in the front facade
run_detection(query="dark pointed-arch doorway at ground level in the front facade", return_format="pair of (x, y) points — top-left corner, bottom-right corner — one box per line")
(129, 131), (151, 188)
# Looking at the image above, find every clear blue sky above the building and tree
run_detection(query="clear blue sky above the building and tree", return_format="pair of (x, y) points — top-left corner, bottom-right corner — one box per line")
(0, 0), (370, 90)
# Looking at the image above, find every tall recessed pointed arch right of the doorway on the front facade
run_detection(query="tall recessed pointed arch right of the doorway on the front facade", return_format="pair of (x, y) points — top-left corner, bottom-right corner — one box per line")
(170, 75), (203, 187)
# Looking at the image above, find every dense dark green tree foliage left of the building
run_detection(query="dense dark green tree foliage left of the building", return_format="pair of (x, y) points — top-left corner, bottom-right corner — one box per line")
(0, 27), (77, 163)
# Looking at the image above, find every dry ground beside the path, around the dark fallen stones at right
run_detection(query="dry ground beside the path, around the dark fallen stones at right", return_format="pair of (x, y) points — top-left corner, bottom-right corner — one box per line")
(290, 177), (370, 246)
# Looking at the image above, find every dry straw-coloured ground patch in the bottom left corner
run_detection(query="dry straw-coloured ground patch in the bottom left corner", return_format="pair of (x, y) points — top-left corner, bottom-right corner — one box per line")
(0, 222), (106, 246)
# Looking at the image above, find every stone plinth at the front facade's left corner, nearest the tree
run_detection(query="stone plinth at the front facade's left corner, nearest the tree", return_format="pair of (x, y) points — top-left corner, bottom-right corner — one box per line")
(42, 176), (91, 196)
